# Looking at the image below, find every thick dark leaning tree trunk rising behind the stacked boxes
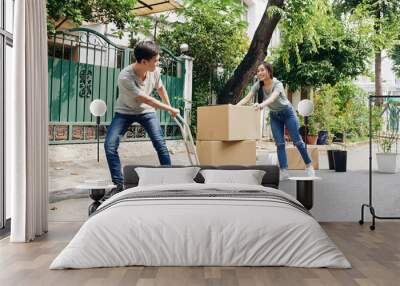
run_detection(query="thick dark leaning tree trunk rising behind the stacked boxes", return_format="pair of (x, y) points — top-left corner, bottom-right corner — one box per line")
(218, 0), (285, 104)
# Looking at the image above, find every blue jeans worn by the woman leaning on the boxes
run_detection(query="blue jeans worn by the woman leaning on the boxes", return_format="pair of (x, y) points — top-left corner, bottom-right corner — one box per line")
(269, 106), (311, 169)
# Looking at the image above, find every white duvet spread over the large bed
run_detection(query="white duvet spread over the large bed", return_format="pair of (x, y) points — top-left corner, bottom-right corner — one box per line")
(50, 184), (351, 269)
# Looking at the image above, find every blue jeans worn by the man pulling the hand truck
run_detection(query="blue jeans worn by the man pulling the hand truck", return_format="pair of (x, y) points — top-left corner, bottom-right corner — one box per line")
(104, 112), (171, 184)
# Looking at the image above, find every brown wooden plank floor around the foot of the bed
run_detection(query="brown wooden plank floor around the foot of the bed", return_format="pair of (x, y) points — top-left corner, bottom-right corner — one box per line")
(0, 222), (400, 286)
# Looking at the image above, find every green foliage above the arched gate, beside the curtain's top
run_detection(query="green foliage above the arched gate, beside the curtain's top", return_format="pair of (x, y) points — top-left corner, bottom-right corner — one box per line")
(47, 0), (137, 32)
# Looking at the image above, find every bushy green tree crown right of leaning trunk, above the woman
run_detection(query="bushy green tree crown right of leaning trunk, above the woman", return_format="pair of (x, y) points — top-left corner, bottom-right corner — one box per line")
(273, 3), (372, 91)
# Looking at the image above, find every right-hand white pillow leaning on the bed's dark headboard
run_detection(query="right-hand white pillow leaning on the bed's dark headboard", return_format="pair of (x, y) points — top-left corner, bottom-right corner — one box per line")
(200, 170), (265, 185)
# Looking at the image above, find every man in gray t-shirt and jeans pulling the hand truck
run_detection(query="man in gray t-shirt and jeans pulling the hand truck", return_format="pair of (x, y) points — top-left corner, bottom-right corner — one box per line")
(104, 41), (179, 198)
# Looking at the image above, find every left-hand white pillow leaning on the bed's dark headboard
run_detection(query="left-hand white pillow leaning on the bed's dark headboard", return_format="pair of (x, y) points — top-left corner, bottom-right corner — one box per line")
(135, 167), (200, 186)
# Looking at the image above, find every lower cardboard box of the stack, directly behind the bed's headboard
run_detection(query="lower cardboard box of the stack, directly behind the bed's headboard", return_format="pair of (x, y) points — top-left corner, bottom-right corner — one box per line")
(196, 140), (256, 165)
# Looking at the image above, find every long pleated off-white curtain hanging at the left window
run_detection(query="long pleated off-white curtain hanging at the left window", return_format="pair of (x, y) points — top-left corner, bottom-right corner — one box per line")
(6, 0), (48, 242)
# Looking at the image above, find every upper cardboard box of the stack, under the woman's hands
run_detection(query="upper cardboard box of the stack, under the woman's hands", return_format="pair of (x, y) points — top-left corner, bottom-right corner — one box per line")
(197, 104), (261, 141)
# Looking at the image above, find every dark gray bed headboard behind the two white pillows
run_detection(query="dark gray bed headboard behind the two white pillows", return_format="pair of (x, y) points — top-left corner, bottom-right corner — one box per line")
(123, 165), (279, 189)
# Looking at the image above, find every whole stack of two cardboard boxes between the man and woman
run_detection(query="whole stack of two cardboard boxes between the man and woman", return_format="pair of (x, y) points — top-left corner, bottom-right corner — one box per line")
(196, 105), (261, 165)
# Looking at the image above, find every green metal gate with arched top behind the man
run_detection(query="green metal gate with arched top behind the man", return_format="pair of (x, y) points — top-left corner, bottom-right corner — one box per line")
(48, 28), (185, 144)
